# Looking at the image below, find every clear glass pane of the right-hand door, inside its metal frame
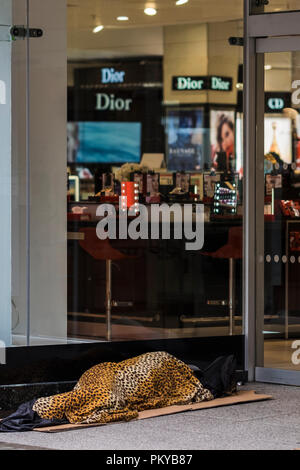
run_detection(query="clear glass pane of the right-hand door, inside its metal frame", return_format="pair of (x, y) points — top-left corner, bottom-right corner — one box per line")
(263, 48), (300, 371)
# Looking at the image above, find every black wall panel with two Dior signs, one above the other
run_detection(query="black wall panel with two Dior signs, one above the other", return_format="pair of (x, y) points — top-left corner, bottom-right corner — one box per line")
(68, 57), (164, 157)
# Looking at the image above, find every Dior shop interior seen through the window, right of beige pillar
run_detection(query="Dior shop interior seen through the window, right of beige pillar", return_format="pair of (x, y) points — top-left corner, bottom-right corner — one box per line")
(67, 2), (243, 341)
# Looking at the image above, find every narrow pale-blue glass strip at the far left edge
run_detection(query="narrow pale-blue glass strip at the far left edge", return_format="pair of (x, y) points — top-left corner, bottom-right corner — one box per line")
(0, 0), (29, 348)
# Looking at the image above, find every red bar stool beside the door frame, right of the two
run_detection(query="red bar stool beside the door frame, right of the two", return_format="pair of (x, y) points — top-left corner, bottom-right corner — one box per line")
(201, 226), (243, 336)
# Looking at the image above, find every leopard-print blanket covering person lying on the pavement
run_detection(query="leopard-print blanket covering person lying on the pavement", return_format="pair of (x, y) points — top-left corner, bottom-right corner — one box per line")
(33, 352), (214, 423)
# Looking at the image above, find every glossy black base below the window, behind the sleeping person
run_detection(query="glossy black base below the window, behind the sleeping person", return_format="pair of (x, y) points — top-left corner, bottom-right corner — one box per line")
(0, 335), (247, 409)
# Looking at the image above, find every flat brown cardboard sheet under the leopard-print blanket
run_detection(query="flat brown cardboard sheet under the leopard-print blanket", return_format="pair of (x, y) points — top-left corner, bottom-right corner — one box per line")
(34, 390), (272, 432)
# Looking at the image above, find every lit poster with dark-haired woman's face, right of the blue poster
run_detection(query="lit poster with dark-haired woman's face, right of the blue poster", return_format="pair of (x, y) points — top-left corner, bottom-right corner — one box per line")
(210, 110), (235, 170)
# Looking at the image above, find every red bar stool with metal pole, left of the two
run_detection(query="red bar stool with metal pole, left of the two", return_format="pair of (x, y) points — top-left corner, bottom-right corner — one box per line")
(79, 227), (135, 341)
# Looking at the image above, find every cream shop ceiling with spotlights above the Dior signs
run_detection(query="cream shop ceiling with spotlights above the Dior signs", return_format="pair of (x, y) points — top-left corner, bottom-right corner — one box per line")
(68, 0), (243, 60)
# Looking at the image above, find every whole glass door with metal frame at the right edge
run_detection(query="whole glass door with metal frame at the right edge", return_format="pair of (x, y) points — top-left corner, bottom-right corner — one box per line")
(256, 38), (300, 385)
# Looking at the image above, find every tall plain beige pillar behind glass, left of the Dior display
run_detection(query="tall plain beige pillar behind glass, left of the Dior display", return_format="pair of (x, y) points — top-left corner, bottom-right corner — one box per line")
(9, 0), (67, 346)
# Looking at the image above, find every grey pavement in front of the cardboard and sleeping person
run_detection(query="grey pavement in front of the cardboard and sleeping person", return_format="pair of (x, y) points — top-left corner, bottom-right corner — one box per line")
(0, 383), (300, 451)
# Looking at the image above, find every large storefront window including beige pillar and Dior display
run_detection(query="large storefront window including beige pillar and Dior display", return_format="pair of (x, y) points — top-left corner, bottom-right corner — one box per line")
(8, 0), (244, 345)
